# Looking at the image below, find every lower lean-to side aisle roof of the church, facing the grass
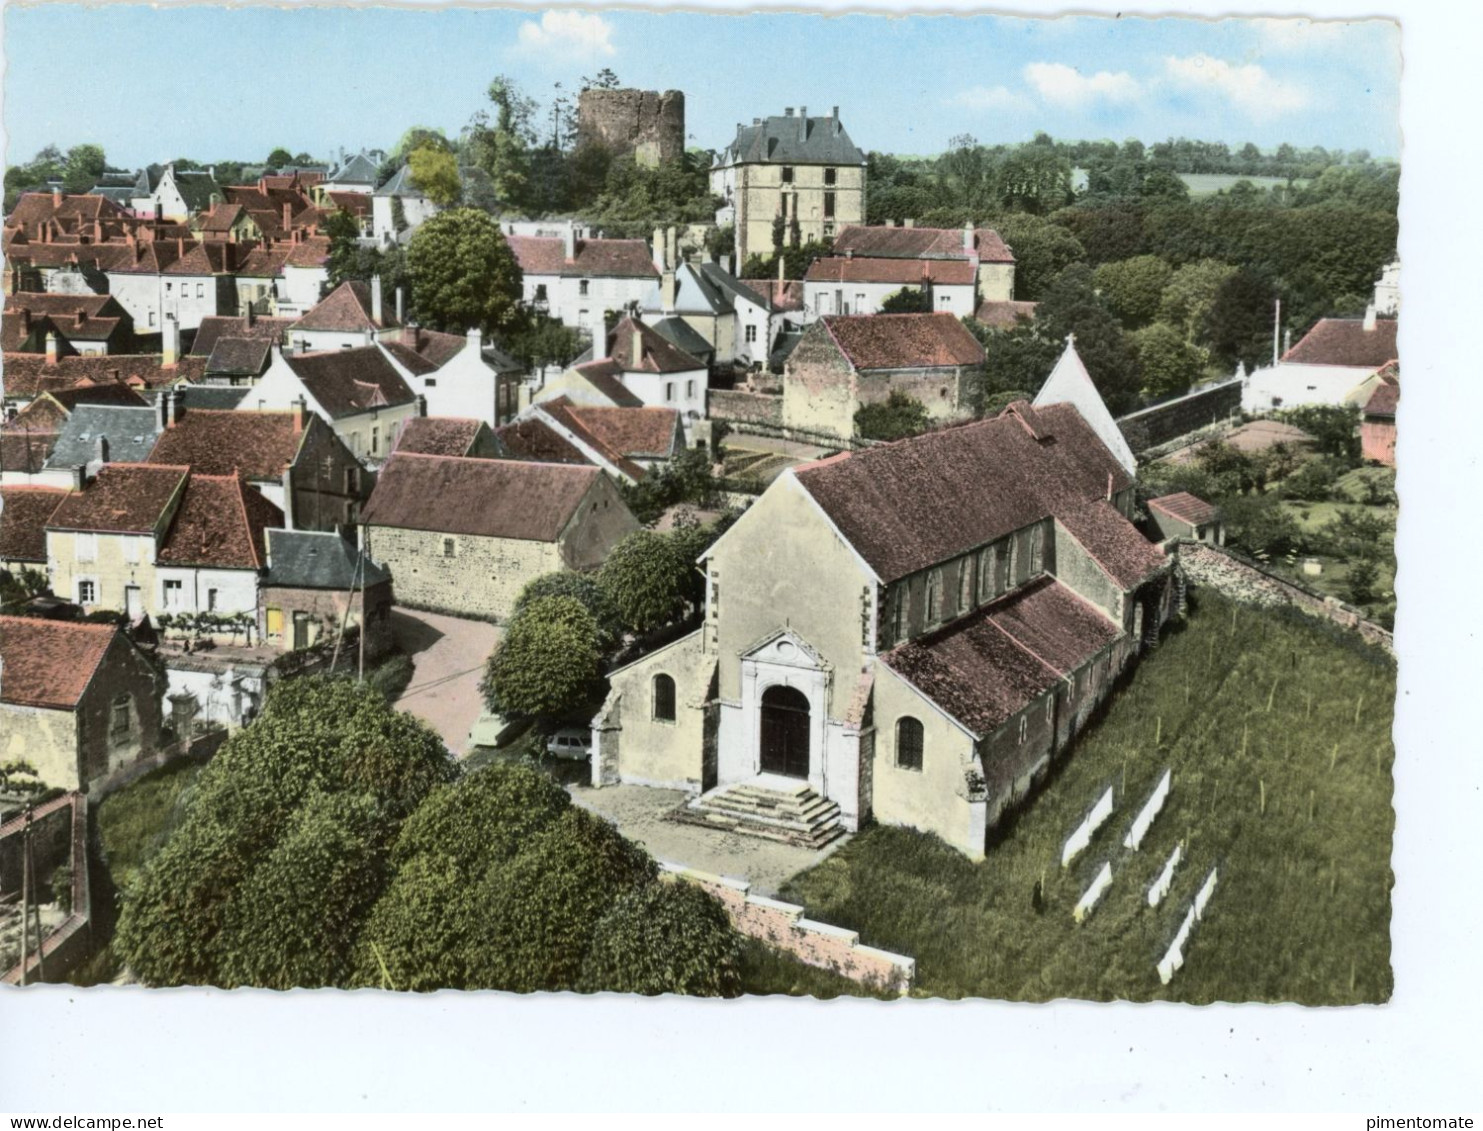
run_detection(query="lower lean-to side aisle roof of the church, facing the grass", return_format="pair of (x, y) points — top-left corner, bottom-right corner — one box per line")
(881, 577), (1120, 738)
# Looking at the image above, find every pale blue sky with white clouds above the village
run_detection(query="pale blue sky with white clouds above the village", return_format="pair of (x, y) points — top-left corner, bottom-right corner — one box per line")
(3, 3), (1400, 168)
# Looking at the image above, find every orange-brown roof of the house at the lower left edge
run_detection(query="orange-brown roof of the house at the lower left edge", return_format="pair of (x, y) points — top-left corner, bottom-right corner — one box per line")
(0, 617), (120, 710)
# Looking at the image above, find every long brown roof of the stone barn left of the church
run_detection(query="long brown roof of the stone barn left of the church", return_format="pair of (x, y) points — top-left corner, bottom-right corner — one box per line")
(362, 452), (602, 542)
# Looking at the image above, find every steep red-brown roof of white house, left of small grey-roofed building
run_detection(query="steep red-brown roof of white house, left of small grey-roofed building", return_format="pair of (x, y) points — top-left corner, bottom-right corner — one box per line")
(156, 474), (283, 569)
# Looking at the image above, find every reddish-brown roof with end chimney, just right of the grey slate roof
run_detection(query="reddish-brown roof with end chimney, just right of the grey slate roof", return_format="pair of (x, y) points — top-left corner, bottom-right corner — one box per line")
(145, 409), (306, 482)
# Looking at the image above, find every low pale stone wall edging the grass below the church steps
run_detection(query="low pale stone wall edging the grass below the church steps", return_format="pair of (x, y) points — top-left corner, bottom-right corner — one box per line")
(660, 861), (916, 995)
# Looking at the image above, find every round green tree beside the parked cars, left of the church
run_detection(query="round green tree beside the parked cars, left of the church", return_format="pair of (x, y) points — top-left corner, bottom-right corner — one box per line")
(479, 596), (602, 719)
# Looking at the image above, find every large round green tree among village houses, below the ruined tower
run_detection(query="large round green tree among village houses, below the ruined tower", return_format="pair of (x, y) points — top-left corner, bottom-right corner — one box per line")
(406, 208), (521, 334)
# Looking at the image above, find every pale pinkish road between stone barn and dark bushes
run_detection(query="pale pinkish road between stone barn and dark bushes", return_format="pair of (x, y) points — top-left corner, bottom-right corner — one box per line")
(392, 608), (501, 754)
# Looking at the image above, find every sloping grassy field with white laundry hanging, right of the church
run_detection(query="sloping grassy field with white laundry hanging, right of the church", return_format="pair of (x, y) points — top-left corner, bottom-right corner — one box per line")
(783, 591), (1396, 1004)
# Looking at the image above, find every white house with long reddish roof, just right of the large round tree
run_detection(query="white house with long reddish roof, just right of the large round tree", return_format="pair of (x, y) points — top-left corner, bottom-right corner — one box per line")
(506, 227), (663, 341)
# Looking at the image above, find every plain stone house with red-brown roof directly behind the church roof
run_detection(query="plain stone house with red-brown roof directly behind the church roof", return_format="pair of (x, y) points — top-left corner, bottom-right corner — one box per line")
(783, 314), (983, 437)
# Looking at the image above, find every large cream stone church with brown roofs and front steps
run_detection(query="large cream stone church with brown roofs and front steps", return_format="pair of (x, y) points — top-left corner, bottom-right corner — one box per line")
(592, 347), (1173, 860)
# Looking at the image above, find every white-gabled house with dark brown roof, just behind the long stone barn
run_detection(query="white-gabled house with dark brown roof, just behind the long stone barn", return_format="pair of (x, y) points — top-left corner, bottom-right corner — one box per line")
(237, 337), (423, 467)
